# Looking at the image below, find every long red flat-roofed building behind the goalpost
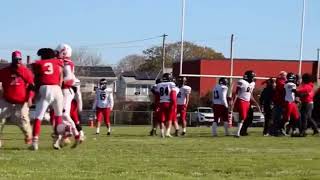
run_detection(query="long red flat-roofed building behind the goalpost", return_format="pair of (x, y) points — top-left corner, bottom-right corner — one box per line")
(173, 59), (318, 96)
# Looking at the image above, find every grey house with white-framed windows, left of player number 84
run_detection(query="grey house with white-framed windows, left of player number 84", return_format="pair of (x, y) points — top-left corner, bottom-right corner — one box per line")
(116, 71), (160, 102)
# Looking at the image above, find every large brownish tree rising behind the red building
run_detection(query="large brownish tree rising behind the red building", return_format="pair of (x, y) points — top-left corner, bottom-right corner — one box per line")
(139, 42), (224, 71)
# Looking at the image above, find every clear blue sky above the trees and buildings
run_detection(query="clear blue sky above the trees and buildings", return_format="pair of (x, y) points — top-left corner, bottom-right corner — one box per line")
(0, 0), (320, 64)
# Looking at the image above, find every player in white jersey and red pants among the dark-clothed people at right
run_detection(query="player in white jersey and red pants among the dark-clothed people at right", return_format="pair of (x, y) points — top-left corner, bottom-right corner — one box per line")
(283, 72), (300, 136)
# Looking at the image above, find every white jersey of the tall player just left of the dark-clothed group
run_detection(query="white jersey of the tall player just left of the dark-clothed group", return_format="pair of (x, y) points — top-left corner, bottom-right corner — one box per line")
(237, 79), (256, 101)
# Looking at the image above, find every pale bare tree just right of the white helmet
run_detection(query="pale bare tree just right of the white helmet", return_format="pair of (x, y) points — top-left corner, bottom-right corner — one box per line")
(71, 48), (102, 66)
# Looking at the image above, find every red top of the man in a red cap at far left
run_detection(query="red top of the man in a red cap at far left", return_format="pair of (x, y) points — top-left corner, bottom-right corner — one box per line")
(0, 65), (33, 104)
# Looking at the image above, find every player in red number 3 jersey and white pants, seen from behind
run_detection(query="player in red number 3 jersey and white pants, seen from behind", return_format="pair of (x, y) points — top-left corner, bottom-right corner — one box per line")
(31, 48), (63, 150)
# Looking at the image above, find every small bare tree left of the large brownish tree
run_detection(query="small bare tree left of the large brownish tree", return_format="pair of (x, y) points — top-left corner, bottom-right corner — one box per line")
(115, 54), (146, 74)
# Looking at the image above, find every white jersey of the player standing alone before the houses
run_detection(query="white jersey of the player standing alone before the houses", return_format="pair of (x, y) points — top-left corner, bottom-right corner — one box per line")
(93, 88), (114, 109)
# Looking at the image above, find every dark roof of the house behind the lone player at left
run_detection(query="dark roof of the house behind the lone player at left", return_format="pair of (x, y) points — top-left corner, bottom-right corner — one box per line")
(75, 66), (116, 77)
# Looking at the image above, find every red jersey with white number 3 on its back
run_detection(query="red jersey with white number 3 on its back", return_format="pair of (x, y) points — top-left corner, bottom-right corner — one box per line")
(34, 59), (63, 86)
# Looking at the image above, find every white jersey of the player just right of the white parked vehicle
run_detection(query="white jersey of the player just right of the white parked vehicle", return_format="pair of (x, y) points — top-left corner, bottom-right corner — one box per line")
(212, 84), (228, 107)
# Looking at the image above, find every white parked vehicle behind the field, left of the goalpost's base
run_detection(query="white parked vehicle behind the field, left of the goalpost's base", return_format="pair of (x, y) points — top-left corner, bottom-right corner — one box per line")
(191, 107), (214, 126)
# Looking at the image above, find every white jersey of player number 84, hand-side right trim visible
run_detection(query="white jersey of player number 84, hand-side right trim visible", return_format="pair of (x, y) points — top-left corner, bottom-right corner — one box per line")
(156, 82), (176, 103)
